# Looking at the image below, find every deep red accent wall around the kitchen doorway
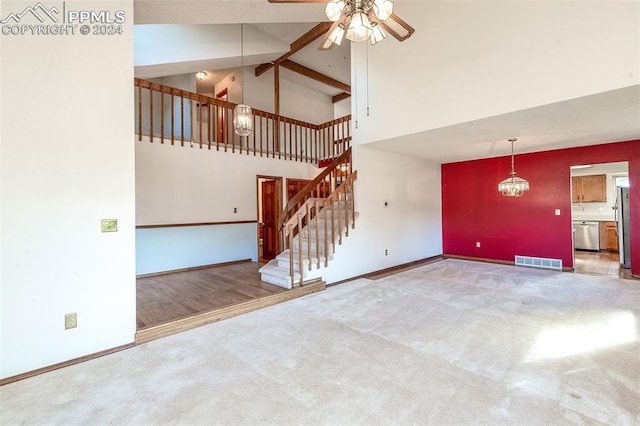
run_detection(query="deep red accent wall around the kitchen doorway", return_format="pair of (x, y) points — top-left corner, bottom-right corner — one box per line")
(442, 140), (640, 275)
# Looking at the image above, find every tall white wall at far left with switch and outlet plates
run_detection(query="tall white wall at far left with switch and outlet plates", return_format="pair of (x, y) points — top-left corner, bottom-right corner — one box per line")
(0, 0), (136, 378)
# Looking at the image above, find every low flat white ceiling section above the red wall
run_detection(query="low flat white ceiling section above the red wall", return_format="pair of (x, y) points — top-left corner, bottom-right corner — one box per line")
(371, 86), (640, 163)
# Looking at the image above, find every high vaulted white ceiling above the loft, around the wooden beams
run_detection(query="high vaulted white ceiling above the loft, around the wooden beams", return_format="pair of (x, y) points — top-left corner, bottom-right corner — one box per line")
(135, 0), (351, 100)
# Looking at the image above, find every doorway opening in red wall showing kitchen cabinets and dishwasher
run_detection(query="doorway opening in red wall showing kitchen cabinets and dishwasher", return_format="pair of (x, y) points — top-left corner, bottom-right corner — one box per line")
(571, 161), (630, 278)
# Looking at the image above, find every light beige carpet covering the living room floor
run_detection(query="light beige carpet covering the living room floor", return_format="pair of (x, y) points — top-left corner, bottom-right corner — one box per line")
(0, 260), (640, 425)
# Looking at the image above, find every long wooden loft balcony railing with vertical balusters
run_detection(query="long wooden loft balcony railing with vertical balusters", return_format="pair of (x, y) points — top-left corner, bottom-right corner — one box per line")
(134, 78), (351, 164)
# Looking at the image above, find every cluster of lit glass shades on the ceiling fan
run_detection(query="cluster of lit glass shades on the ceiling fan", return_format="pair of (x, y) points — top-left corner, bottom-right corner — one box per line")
(325, 0), (393, 46)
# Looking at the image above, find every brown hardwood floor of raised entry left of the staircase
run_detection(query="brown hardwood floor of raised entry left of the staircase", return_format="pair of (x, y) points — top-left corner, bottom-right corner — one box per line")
(136, 262), (287, 330)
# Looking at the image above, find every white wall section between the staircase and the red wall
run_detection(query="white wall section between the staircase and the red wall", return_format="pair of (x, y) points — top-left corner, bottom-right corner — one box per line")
(322, 146), (442, 283)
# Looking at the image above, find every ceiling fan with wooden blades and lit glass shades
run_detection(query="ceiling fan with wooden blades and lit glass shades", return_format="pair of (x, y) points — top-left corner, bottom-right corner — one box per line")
(269, 0), (415, 50)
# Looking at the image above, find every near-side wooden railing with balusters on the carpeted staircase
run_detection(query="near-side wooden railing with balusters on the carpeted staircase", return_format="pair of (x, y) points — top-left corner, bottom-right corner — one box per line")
(284, 172), (358, 287)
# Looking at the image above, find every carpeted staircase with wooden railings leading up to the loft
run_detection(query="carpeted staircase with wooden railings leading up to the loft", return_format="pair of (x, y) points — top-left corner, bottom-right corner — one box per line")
(260, 149), (358, 289)
